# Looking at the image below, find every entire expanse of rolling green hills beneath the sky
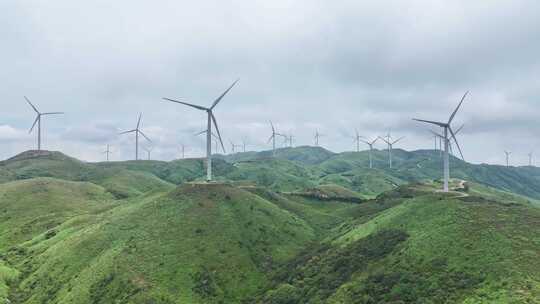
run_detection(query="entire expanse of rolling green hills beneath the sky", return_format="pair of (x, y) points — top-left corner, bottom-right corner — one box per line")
(0, 147), (540, 304)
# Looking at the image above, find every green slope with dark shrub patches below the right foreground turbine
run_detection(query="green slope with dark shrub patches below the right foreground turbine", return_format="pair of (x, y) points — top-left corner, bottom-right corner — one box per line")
(261, 183), (540, 303)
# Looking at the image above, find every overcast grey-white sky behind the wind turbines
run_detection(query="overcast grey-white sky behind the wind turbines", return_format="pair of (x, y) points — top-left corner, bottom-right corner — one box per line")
(0, 0), (540, 164)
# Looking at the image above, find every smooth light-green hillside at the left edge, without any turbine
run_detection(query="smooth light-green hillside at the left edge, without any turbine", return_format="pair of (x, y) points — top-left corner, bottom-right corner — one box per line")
(0, 178), (115, 251)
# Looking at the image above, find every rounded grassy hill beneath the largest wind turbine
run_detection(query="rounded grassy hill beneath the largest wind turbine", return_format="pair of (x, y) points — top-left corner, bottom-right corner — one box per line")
(4, 184), (315, 303)
